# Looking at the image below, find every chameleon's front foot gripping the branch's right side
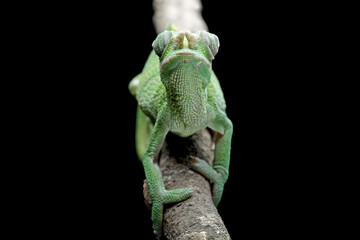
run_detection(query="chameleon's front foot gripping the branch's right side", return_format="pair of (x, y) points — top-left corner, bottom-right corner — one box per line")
(190, 157), (229, 206)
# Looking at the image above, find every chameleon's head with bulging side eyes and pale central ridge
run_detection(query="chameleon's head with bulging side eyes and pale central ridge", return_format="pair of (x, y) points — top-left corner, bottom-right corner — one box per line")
(152, 31), (220, 87)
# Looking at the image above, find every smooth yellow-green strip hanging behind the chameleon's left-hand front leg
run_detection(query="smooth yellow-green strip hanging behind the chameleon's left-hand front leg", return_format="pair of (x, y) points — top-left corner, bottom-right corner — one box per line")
(135, 106), (153, 161)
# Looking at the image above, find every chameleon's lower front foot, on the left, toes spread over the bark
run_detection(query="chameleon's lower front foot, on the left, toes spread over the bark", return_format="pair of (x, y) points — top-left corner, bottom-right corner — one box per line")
(151, 188), (192, 238)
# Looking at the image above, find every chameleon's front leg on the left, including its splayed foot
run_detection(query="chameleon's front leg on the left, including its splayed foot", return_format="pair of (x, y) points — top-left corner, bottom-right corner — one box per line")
(142, 116), (192, 238)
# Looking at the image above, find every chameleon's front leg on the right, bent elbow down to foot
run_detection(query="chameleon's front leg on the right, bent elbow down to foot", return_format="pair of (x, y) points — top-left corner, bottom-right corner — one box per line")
(190, 113), (233, 206)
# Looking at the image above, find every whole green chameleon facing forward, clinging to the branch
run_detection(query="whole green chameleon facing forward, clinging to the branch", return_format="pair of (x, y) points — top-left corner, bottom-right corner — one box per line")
(129, 25), (233, 237)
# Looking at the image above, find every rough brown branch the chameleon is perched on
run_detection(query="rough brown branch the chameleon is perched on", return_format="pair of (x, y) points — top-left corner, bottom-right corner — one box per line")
(144, 0), (230, 240)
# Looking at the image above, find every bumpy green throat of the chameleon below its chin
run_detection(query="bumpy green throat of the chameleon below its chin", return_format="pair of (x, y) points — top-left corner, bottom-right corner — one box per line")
(161, 63), (209, 126)
